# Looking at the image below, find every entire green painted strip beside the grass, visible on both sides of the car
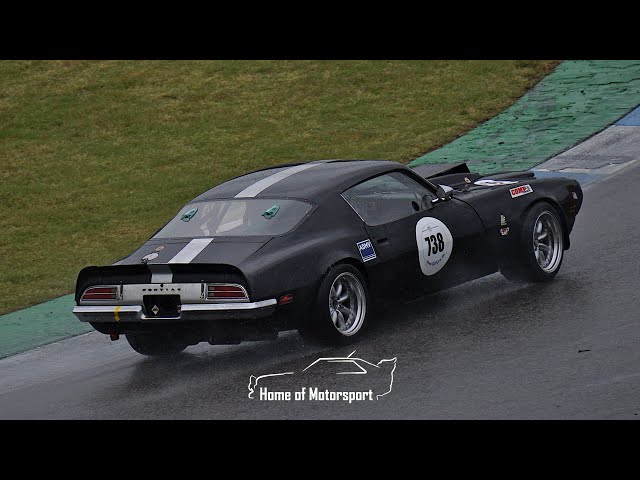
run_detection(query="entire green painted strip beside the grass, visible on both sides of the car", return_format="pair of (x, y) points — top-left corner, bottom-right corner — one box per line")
(5, 61), (640, 358)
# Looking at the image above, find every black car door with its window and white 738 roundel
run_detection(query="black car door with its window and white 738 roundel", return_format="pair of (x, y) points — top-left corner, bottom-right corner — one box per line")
(343, 171), (492, 296)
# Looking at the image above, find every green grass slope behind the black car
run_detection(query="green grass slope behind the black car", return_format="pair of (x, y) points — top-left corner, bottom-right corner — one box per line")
(0, 61), (557, 313)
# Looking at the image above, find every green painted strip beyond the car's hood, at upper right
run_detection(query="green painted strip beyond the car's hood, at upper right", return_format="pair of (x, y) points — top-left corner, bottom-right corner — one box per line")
(410, 60), (640, 173)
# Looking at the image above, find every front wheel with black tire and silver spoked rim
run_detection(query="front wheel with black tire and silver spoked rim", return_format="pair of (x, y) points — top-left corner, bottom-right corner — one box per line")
(501, 202), (565, 282)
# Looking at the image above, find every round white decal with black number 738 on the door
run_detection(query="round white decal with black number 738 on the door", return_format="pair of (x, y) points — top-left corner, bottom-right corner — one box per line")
(416, 217), (453, 275)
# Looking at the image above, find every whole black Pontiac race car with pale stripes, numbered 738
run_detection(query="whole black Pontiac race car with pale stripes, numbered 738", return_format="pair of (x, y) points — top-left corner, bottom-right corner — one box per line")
(73, 160), (582, 355)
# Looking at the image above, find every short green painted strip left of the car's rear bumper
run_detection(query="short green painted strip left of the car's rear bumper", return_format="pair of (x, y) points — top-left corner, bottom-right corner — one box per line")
(0, 295), (91, 358)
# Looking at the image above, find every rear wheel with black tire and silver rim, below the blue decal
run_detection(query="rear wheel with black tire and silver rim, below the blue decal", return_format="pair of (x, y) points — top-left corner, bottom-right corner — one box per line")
(298, 263), (372, 345)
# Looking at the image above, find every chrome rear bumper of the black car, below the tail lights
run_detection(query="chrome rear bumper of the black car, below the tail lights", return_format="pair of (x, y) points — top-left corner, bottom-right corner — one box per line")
(73, 298), (278, 323)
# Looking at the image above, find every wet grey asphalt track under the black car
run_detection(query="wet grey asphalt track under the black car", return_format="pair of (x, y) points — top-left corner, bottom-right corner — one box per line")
(0, 162), (640, 419)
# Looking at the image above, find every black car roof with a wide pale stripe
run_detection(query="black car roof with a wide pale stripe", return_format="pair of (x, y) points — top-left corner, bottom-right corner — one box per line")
(194, 160), (407, 202)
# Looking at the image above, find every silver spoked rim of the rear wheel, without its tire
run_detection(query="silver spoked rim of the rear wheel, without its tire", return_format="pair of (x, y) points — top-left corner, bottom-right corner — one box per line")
(329, 272), (367, 337)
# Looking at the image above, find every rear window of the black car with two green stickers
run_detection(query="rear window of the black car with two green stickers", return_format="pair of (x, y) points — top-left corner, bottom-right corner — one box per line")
(154, 198), (313, 238)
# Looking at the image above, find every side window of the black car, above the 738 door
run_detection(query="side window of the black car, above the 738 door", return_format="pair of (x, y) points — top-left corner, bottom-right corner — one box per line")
(342, 172), (430, 226)
